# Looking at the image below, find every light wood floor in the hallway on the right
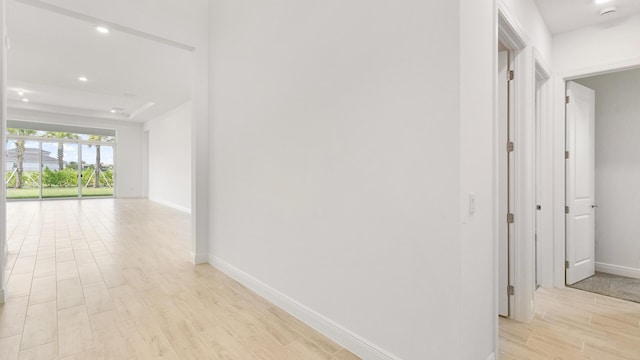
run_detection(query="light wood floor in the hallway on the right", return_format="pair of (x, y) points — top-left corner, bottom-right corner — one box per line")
(500, 288), (640, 360)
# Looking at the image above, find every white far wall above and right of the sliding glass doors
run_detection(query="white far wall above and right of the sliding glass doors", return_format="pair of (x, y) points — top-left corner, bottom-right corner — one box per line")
(8, 109), (143, 198)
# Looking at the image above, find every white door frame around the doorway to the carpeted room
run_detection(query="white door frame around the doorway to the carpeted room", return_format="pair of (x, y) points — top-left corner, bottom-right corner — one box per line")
(553, 58), (640, 288)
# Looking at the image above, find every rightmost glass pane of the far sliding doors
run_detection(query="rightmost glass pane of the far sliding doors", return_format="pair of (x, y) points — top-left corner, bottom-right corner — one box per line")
(82, 145), (114, 197)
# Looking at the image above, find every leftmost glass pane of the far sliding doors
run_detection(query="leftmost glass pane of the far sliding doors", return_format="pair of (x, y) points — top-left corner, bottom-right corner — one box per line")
(5, 139), (41, 199)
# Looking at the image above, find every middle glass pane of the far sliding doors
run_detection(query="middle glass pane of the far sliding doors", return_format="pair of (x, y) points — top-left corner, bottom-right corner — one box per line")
(42, 140), (78, 198)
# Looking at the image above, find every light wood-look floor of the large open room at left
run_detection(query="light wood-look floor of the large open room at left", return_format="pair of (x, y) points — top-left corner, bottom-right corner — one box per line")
(0, 199), (358, 360)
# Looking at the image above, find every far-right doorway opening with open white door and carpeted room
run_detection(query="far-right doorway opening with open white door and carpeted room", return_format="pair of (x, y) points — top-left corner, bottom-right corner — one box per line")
(565, 68), (640, 302)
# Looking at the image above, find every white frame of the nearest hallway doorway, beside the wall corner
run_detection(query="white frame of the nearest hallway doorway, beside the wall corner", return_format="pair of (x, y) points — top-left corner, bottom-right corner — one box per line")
(494, 2), (535, 321)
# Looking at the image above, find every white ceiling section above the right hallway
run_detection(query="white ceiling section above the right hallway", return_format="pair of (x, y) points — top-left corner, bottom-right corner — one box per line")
(534, 0), (640, 35)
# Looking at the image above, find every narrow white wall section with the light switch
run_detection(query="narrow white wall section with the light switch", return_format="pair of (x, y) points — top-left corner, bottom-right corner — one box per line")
(462, 0), (498, 360)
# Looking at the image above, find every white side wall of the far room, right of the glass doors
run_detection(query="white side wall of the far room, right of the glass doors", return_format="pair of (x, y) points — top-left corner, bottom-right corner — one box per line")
(144, 103), (191, 212)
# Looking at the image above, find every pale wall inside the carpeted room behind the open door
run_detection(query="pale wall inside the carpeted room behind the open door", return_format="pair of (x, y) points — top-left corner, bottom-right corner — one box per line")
(578, 69), (640, 277)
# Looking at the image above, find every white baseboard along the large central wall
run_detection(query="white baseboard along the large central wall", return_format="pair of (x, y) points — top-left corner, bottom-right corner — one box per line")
(209, 255), (400, 360)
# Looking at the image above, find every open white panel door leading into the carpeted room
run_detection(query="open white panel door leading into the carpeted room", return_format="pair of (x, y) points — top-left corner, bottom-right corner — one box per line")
(565, 81), (595, 285)
